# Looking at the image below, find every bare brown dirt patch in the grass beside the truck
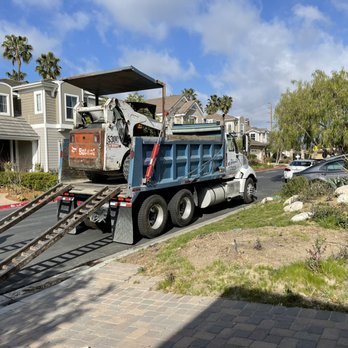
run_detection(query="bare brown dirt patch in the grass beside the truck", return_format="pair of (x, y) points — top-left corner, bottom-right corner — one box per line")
(180, 226), (348, 269)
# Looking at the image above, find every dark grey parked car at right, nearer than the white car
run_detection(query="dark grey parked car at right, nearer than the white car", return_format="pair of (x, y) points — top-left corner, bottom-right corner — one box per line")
(294, 154), (348, 181)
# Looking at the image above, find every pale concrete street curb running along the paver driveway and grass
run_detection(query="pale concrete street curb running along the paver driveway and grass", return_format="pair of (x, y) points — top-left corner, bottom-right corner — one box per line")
(0, 204), (254, 314)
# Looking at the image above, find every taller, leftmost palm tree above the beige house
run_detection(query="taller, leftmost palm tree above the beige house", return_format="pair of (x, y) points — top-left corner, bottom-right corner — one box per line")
(1, 34), (33, 81)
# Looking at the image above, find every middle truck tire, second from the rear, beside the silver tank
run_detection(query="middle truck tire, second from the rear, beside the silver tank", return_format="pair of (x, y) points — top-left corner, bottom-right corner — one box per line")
(168, 189), (195, 227)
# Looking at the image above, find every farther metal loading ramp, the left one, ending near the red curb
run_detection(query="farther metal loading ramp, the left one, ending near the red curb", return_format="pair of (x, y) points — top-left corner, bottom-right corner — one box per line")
(0, 184), (72, 234)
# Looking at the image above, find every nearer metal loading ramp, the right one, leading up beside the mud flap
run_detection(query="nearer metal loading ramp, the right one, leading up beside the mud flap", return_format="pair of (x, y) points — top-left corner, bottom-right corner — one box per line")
(0, 186), (120, 280)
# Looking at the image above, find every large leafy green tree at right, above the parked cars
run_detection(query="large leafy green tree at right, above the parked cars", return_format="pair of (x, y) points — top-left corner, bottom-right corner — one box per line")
(275, 69), (348, 150)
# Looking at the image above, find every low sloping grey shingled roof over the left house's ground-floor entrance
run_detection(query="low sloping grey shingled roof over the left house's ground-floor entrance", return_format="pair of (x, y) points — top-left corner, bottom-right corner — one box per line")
(0, 116), (39, 141)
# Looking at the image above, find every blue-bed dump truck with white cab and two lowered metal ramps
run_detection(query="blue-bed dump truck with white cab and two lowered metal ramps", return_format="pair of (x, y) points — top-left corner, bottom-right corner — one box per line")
(0, 67), (257, 280)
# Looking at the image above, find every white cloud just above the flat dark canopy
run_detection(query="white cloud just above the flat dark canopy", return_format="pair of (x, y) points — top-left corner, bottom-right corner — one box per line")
(118, 48), (196, 82)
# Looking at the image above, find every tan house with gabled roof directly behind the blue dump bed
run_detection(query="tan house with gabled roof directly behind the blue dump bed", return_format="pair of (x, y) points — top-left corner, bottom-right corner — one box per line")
(146, 95), (204, 124)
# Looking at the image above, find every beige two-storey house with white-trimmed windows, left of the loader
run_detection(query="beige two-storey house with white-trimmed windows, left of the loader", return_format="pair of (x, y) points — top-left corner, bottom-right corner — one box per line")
(0, 79), (89, 171)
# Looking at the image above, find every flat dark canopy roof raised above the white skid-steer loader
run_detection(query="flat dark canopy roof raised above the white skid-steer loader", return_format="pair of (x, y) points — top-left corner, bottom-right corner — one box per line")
(63, 66), (164, 95)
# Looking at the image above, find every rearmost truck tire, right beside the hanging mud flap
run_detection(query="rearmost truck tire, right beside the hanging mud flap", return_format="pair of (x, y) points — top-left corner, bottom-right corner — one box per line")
(137, 195), (168, 238)
